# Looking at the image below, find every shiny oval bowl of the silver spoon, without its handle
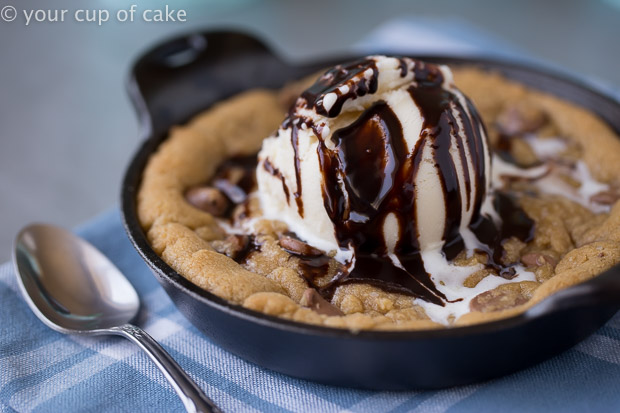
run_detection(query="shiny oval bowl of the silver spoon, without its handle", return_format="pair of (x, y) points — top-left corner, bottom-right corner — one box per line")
(15, 224), (140, 334)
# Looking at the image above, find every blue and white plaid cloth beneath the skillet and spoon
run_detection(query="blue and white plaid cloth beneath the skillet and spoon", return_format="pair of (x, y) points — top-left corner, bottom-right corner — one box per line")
(0, 21), (620, 413)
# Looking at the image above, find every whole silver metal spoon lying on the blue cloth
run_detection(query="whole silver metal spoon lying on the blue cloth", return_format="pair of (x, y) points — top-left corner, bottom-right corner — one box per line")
(13, 224), (220, 412)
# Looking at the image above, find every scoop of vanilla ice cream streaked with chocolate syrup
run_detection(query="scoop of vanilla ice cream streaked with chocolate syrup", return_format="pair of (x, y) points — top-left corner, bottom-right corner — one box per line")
(256, 56), (492, 262)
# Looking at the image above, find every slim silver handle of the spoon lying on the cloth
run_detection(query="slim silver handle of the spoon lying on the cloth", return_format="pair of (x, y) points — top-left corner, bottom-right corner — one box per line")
(110, 324), (221, 413)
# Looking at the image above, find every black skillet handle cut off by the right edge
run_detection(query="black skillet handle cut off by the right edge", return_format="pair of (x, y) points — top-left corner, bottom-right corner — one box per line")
(525, 266), (620, 317)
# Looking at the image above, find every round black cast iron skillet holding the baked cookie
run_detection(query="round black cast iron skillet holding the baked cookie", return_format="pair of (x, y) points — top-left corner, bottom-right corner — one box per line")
(122, 32), (620, 389)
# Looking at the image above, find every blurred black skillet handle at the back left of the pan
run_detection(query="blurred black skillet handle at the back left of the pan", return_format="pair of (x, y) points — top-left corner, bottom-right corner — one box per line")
(127, 31), (285, 137)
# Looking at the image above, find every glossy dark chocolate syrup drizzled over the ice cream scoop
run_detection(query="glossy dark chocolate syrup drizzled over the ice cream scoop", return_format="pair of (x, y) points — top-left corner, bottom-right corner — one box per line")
(264, 58), (533, 305)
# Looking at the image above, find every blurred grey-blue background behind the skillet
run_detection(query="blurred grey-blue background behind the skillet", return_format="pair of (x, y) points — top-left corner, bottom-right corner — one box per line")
(0, 0), (620, 262)
